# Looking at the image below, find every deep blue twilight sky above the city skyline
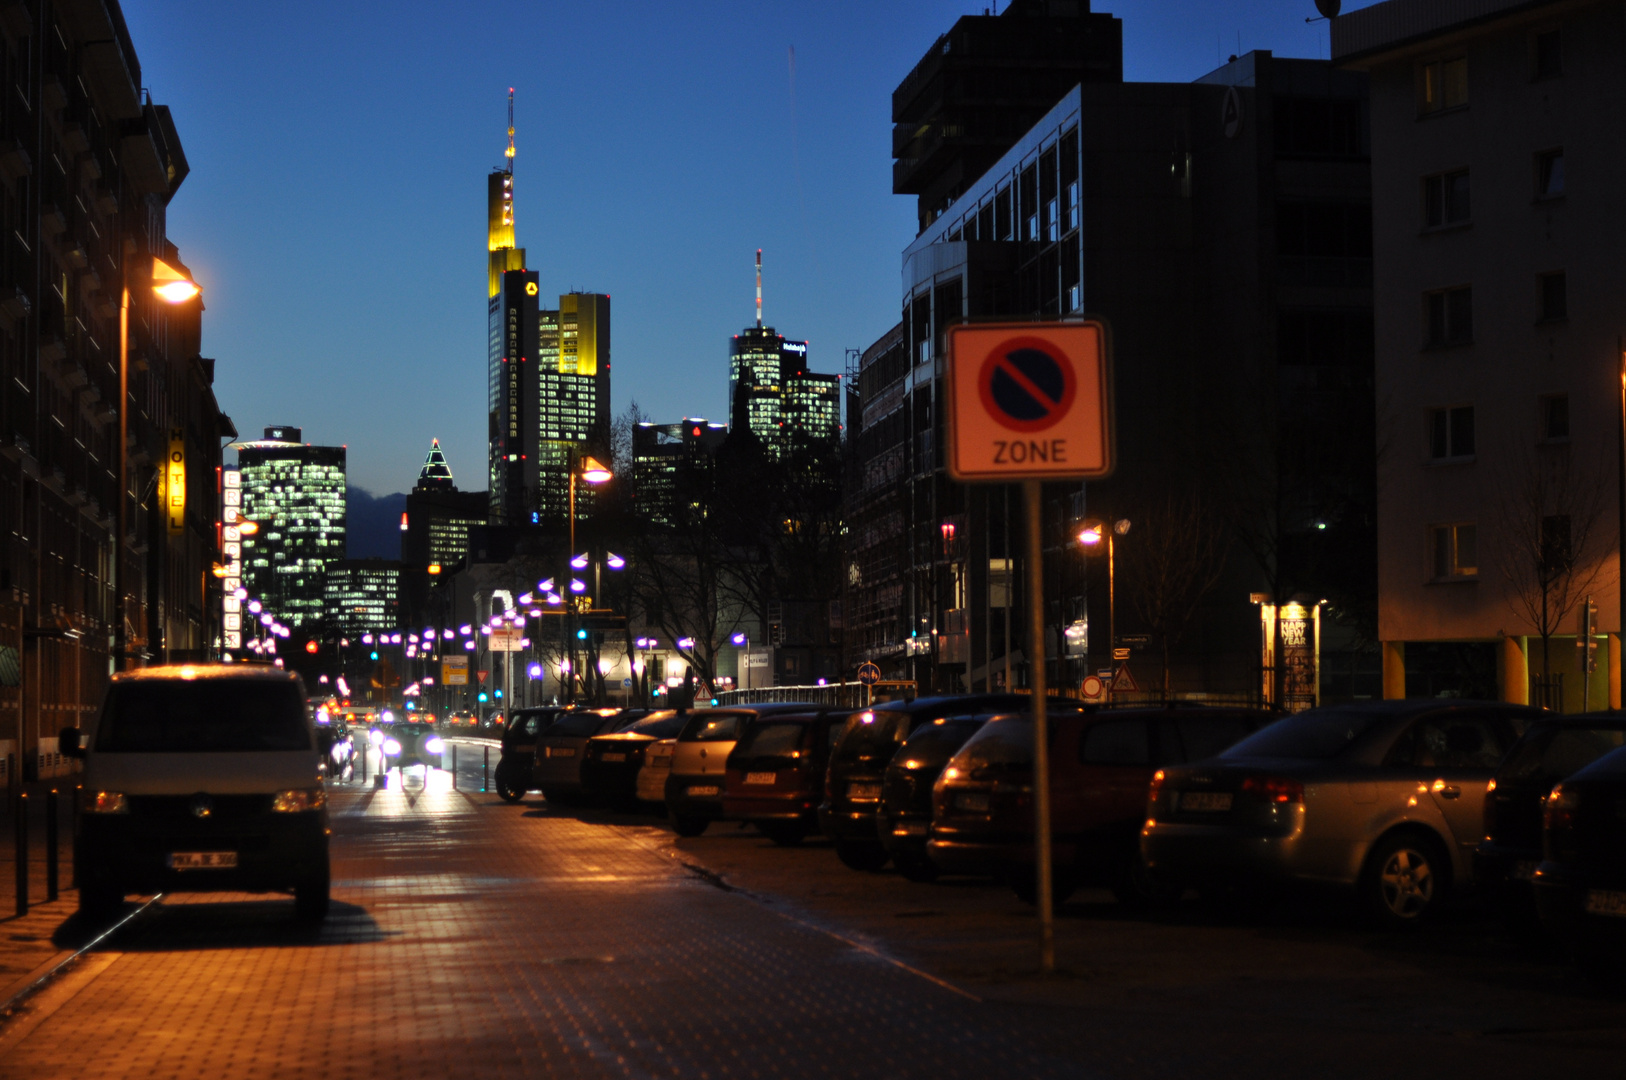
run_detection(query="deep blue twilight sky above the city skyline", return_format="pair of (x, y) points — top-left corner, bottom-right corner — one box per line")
(124, 0), (1366, 493)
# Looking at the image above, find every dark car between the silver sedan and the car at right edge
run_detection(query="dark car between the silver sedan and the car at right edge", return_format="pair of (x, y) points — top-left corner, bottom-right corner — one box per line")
(1476, 712), (1626, 925)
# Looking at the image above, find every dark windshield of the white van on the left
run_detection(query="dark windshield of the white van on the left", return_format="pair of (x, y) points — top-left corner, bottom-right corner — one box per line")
(96, 678), (312, 753)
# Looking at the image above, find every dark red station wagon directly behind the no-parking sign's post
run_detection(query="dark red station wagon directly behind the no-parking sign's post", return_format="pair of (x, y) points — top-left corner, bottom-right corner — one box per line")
(927, 706), (1275, 904)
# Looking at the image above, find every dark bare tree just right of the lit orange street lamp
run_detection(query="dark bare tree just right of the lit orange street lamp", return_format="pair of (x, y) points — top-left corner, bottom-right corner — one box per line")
(1122, 491), (1231, 698)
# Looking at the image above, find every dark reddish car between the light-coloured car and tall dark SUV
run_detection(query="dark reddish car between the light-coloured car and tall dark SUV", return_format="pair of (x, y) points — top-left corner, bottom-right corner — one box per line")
(722, 709), (849, 847)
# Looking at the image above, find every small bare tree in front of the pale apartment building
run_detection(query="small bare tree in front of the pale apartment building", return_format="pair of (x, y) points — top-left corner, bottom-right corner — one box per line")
(1495, 446), (1615, 699)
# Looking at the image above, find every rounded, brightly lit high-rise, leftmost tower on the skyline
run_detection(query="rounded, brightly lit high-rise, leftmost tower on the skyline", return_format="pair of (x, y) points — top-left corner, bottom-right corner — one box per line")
(231, 426), (345, 628)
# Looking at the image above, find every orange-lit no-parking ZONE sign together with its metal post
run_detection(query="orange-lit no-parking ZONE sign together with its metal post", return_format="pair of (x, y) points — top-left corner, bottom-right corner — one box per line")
(946, 320), (1114, 973)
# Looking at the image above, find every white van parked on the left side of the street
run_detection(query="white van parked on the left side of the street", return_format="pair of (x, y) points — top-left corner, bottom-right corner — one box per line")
(59, 664), (330, 921)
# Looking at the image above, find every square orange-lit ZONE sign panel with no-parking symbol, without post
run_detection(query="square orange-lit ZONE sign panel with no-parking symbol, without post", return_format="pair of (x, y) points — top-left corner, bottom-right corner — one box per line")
(946, 322), (1114, 481)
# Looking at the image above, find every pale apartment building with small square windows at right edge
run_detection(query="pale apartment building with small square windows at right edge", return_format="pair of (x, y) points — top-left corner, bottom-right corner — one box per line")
(1332, 0), (1626, 712)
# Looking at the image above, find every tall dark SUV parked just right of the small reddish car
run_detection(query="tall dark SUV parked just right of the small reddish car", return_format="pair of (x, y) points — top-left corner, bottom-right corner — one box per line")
(818, 695), (1028, 870)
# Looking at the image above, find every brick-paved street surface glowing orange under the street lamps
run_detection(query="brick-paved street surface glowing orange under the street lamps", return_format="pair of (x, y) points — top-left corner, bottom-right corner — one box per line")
(0, 741), (1626, 1080)
